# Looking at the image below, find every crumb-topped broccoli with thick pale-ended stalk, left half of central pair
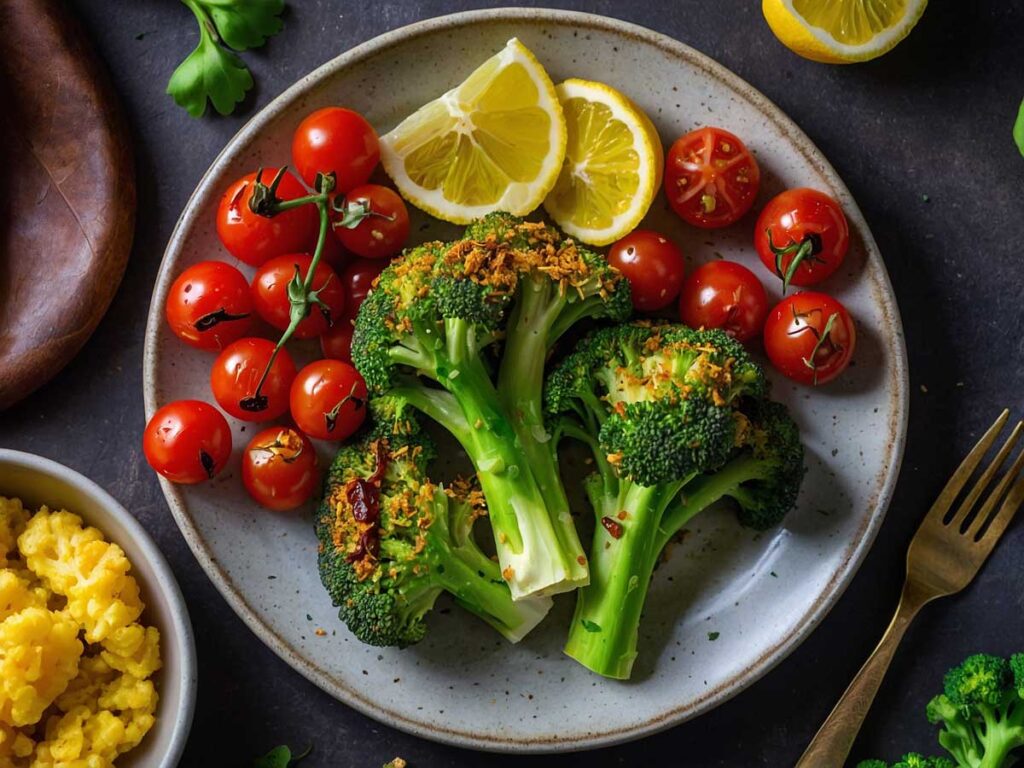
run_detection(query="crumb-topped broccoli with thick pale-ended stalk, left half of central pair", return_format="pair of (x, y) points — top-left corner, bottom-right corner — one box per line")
(352, 240), (588, 599)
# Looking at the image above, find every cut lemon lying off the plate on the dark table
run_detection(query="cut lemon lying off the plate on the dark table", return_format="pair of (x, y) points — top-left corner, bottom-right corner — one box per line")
(761, 0), (928, 63)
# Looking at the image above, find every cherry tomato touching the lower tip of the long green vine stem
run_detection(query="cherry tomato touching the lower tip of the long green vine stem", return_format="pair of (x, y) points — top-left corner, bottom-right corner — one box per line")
(210, 337), (295, 422)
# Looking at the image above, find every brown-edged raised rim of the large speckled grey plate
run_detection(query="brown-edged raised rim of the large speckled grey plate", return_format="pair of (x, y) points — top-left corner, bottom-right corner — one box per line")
(142, 8), (909, 753)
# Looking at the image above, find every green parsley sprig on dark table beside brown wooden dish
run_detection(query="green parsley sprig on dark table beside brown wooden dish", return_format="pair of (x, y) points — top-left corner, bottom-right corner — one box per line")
(167, 0), (285, 118)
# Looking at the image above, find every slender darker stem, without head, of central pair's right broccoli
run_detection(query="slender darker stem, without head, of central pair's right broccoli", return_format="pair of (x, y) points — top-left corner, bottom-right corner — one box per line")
(498, 278), (588, 586)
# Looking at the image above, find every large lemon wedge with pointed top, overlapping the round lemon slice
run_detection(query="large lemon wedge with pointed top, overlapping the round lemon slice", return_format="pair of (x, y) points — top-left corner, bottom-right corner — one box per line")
(381, 38), (565, 224)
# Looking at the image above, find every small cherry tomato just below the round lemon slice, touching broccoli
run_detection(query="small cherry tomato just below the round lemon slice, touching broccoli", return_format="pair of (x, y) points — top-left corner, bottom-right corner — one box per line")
(608, 229), (685, 312)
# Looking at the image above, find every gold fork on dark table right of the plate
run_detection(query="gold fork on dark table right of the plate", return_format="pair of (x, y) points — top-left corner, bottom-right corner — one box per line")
(797, 411), (1024, 768)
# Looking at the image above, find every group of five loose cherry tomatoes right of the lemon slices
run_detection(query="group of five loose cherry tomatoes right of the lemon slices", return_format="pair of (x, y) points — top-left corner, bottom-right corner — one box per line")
(651, 127), (856, 385)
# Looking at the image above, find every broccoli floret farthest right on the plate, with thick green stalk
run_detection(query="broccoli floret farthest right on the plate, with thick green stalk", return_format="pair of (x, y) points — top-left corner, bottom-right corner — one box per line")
(545, 323), (804, 678)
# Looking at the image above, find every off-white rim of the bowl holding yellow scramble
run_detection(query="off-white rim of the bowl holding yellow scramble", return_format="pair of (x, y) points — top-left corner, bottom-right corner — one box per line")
(0, 449), (199, 768)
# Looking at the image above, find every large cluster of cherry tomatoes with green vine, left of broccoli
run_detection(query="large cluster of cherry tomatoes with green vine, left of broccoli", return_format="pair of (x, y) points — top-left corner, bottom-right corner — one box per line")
(143, 106), (410, 510)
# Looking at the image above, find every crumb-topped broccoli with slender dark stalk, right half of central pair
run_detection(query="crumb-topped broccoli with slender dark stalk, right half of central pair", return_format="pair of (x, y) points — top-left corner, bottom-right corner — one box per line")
(465, 212), (632, 598)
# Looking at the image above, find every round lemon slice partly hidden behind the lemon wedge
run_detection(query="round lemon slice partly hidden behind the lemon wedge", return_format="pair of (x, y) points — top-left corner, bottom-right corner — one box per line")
(544, 80), (665, 246)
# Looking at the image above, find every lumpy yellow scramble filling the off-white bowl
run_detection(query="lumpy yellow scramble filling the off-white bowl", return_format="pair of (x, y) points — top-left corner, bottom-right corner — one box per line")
(0, 497), (161, 768)
